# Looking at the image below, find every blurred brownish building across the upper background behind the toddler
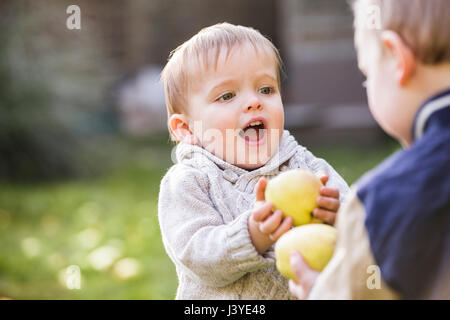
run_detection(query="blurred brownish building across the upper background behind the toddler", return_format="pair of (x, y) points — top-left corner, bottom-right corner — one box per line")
(3, 0), (380, 141)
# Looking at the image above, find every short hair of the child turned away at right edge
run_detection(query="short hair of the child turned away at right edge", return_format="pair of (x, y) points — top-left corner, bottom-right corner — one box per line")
(352, 0), (450, 64)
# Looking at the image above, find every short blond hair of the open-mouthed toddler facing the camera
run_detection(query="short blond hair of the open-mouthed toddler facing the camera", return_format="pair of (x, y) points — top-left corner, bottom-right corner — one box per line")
(161, 22), (283, 138)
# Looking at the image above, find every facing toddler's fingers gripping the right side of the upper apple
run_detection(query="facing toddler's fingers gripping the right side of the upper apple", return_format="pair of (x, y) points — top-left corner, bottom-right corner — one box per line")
(313, 175), (341, 225)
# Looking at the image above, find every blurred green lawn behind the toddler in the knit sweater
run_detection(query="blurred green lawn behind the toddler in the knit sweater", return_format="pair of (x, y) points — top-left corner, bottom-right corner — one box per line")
(0, 139), (396, 299)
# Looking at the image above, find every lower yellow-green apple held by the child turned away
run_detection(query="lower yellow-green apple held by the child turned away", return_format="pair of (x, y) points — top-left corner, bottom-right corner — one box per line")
(275, 224), (337, 280)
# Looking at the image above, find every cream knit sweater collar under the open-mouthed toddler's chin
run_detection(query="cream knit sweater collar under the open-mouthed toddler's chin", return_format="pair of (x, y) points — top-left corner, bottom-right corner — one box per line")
(176, 130), (298, 176)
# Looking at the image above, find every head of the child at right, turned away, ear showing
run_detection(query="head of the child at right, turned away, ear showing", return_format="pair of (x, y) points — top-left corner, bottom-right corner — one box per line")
(353, 0), (450, 146)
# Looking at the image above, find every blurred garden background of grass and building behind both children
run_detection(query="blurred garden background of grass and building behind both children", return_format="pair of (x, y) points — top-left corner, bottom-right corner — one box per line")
(0, 0), (399, 299)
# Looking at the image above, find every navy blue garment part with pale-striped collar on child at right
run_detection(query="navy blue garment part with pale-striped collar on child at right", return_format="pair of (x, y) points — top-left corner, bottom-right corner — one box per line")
(357, 90), (450, 299)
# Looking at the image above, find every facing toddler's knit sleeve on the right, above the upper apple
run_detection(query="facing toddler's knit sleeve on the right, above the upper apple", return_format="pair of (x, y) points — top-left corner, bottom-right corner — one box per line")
(296, 147), (349, 202)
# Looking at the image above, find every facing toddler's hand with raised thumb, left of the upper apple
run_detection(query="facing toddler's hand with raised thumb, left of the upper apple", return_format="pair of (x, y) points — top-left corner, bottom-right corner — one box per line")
(248, 178), (293, 253)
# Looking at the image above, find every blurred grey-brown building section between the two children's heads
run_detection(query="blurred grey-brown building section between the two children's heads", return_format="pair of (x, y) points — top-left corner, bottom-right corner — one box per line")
(278, 0), (383, 142)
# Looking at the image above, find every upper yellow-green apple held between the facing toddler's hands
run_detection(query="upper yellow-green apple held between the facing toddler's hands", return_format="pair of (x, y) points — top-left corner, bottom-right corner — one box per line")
(265, 169), (323, 226)
